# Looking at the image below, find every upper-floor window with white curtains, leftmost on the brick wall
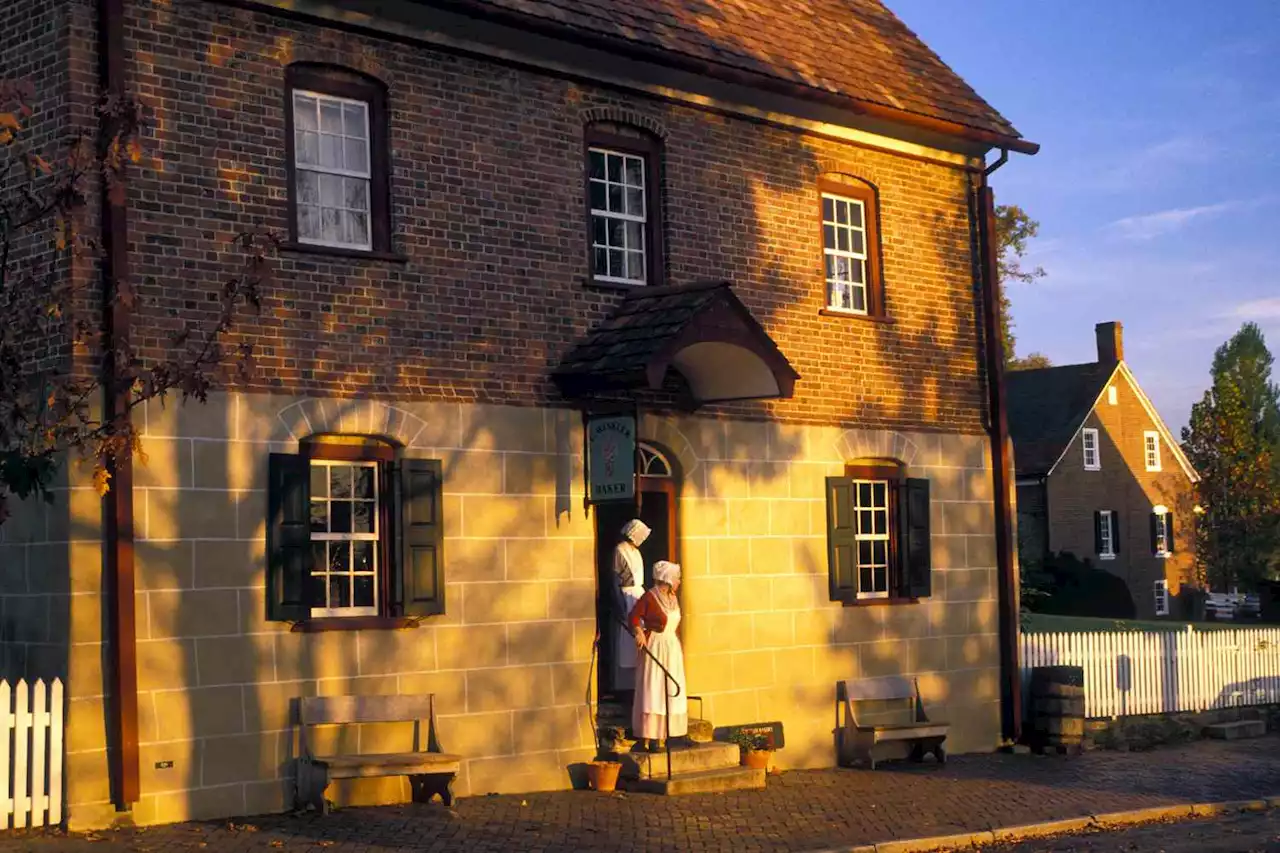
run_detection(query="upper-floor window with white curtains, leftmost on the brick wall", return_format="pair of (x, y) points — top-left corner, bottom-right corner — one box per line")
(285, 64), (390, 252)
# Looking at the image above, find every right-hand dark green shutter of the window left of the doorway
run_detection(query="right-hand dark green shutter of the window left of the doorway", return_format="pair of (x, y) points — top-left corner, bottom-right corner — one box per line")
(397, 459), (444, 616)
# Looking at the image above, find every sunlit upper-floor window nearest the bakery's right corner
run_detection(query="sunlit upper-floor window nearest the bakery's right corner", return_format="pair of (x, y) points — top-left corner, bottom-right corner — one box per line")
(818, 178), (883, 315)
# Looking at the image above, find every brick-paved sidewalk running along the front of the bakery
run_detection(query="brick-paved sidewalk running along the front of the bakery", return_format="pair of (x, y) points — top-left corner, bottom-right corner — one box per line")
(0, 738), (1280, 853)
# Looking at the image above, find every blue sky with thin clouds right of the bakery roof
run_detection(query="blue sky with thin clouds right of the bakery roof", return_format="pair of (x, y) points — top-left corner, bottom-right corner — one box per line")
(886, 0), (1280, 432)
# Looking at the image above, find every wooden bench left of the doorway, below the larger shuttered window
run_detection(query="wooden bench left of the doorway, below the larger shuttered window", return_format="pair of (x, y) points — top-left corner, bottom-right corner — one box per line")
(297, 694), (462, 813)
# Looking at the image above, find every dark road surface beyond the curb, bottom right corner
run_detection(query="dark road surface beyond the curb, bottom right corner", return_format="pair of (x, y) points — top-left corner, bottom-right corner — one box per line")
(982, 811), (1280, 853)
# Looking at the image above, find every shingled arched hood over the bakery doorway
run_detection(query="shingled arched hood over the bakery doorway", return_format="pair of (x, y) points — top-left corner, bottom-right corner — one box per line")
(552, 282), (800, 405)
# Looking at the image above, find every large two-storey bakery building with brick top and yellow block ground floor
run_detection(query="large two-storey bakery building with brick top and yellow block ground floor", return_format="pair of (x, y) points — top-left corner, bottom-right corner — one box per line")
(0, 0), (1036, 827)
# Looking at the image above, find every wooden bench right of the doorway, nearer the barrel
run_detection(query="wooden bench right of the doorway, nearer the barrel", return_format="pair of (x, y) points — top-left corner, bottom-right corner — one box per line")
(836, 676), (948, 770)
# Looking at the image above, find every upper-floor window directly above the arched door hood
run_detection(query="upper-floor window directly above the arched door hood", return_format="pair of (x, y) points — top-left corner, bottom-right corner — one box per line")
(586, 124), (662, 286)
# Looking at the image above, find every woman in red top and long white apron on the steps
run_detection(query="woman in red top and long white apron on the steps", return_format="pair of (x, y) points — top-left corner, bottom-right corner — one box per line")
(630, 560), (689, 752)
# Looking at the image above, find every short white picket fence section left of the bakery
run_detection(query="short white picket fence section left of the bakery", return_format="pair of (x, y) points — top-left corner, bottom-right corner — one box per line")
(0, 679), (63, 830)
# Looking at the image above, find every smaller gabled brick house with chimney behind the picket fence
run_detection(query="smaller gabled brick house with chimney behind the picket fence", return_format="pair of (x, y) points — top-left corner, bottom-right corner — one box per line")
(1007, 323), (1199, 619)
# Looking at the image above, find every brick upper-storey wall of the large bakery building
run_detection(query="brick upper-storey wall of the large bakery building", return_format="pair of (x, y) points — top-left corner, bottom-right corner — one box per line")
(127, 0), (982, 432)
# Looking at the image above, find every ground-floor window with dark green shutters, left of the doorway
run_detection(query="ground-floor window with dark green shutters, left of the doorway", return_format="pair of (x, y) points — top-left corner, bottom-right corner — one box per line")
(266, 435), (444, 624)
